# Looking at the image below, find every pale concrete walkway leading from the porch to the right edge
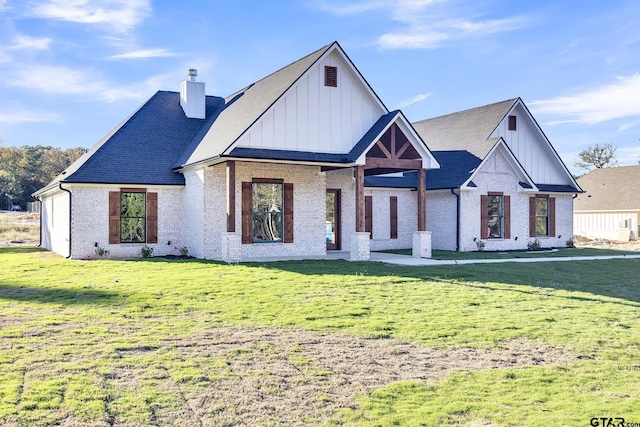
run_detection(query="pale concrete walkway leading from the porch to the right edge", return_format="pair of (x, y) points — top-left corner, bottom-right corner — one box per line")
(241, 251), (640, 266)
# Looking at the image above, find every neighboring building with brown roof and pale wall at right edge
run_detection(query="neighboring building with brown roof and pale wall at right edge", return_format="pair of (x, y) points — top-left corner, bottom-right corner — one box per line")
(573, 165), (640, 241)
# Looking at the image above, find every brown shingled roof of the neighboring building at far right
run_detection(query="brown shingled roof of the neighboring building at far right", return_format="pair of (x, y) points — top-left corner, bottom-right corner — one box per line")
(573, 165), (640, 211)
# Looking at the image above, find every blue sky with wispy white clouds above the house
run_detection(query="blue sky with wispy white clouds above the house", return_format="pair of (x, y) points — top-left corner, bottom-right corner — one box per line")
(0, 0), (640, 171)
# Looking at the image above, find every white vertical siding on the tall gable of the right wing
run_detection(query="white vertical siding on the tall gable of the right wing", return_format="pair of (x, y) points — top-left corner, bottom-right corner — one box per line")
(491, 104), (571, 184)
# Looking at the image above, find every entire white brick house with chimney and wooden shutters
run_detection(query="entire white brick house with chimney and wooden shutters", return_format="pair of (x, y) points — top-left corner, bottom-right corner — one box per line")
(35, 42), (580, 261)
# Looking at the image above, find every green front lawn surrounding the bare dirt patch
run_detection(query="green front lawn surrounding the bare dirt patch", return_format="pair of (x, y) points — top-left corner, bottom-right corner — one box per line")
(0, 248), (640, 426)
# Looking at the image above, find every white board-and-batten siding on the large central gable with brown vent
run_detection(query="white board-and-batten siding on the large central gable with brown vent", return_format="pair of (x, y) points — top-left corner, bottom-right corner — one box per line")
(237, 52), (386, 153)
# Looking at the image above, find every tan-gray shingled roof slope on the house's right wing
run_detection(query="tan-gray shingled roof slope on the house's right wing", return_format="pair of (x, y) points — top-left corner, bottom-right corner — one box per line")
(412, 98), (518, 159)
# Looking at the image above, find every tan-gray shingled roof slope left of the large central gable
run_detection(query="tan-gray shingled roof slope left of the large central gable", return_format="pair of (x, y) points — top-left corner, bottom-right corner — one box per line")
(181, 42), (336, 165)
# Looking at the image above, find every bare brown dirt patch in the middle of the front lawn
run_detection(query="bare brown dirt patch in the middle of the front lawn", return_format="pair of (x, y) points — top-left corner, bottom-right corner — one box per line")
(150, 328), (576, 426)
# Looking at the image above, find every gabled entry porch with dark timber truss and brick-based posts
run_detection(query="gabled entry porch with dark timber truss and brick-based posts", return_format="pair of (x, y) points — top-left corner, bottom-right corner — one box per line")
(322, 112), (439, 261)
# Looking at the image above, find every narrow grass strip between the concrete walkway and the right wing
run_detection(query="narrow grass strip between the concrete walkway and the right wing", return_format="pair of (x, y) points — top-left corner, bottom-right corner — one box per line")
(380, 248), (640, 260)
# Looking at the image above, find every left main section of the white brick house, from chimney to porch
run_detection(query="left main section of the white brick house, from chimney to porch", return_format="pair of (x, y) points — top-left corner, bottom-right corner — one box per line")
(34, 42), (439, 261)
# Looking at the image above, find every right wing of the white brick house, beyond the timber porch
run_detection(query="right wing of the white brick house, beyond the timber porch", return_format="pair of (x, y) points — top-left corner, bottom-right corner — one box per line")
(365, 98), (581, 251)
